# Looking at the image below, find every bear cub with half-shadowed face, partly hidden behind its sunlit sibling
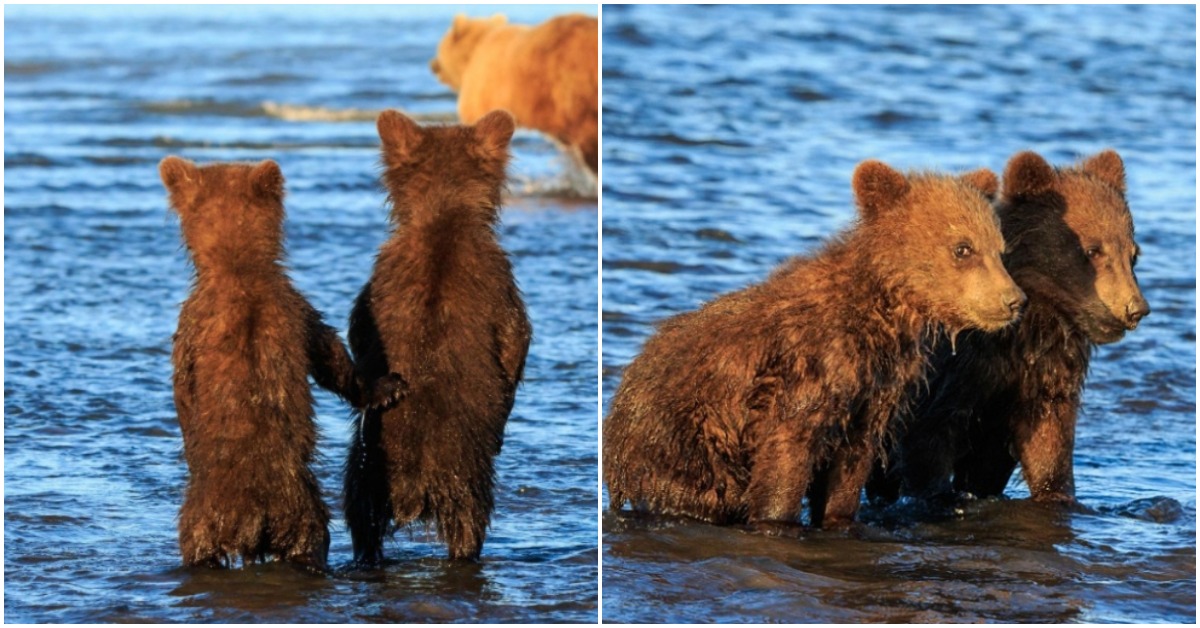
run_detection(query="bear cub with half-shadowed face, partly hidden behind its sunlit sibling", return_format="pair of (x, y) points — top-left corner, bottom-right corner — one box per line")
(869, 150), (1150, 502)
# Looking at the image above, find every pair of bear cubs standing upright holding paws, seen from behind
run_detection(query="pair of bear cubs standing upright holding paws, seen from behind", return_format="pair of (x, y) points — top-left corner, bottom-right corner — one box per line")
(160, 112), (530, 570)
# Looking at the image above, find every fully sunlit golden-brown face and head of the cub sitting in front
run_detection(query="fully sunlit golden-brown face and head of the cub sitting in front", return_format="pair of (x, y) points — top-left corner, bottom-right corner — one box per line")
(853, 161), (1025, 333)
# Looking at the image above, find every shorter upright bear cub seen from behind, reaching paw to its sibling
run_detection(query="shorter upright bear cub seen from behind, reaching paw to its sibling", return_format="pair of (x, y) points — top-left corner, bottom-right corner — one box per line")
(158, 157), (403, 569)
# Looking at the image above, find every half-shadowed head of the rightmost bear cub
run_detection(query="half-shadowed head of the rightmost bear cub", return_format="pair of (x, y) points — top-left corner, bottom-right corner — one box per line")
(997, 150), (1150, 343)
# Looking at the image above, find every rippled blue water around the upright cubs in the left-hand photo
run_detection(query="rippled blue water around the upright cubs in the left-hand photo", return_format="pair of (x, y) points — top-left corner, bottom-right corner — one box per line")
(4, 6), (598, 623)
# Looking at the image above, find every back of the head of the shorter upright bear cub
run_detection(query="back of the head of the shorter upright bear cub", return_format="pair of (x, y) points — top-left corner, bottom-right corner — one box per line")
(158, 156), (283, 268)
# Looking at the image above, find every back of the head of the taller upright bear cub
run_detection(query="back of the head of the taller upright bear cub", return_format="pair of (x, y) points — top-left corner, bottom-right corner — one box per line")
(377, 109), (516, 222)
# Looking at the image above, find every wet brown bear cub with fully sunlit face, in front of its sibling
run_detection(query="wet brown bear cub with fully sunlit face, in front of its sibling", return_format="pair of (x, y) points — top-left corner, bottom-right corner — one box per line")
(604, 161), (1025, 532)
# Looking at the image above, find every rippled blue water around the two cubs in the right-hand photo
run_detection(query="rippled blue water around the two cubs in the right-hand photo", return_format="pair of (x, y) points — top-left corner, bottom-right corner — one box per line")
(602, 6), (1196, 622)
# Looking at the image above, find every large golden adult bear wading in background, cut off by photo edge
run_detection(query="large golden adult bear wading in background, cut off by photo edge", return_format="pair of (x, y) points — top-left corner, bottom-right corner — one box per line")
(430, 14), (599, 174)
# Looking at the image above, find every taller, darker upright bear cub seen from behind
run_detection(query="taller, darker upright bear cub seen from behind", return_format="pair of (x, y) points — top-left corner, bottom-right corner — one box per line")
(346, 110), (532, 564)
